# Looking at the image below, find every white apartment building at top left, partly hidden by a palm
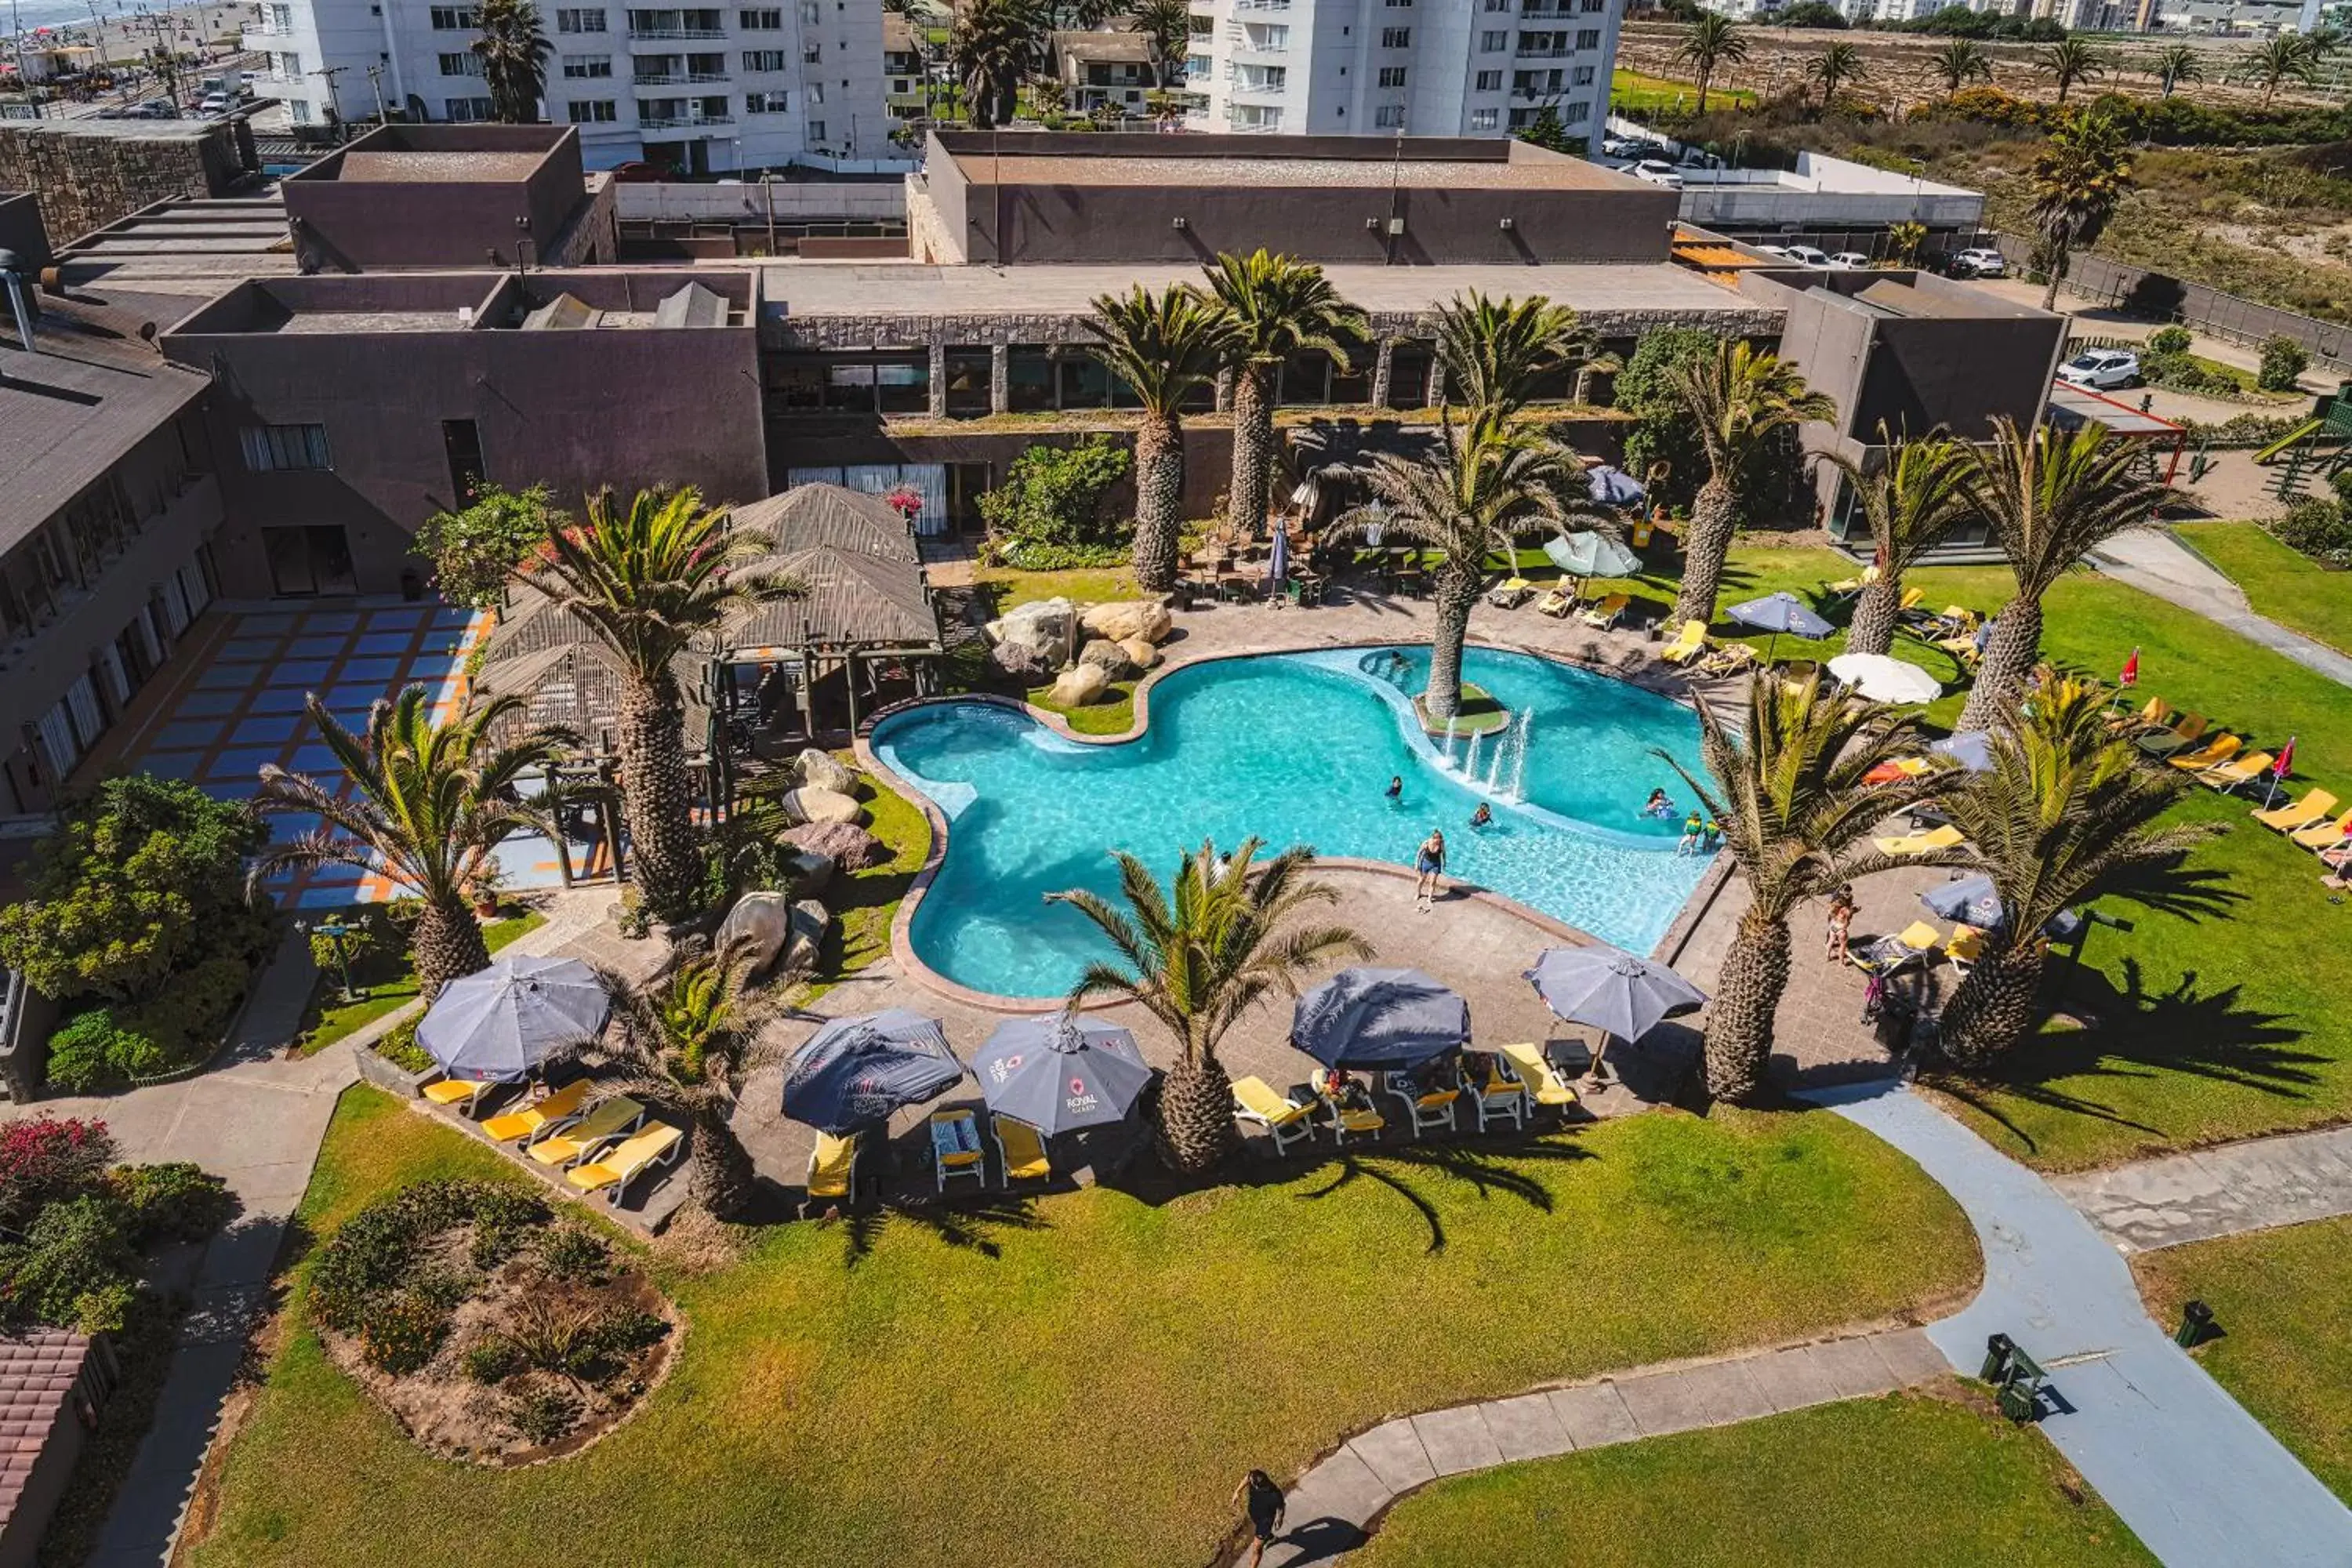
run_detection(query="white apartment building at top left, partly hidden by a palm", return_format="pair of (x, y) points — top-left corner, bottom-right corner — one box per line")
(245, 0), (894, 174)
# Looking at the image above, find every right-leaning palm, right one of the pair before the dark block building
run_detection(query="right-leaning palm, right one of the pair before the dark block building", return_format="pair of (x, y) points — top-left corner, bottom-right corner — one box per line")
(1959, 414), (2169, 729)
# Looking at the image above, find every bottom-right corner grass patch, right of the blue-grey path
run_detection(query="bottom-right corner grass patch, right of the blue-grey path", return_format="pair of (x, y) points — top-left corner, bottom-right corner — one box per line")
(2131, 1218), (2352, 1502)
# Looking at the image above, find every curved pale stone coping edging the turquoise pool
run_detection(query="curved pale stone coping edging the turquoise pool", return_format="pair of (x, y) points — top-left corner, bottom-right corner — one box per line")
(854, 637), (1731, 1013)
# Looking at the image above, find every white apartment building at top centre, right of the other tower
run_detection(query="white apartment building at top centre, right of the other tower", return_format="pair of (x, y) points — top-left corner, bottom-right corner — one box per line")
(1185, 0), (1625, 143)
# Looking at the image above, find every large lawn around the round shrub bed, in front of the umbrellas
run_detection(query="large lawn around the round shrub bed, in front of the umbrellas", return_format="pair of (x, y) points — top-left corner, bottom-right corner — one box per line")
(193, 1086), (1980, 1568)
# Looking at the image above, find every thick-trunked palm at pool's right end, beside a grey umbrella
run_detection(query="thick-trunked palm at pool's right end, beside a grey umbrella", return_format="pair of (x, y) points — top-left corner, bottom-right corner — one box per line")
(1658, 675), (1950, 1100)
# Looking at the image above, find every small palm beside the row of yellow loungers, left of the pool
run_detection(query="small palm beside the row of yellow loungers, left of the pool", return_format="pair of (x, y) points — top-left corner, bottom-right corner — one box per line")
(600, 942), (781, 1220)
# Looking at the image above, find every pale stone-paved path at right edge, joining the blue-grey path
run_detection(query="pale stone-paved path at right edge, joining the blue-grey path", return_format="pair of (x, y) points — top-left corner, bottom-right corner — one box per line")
(2051, 1126), (2352, 1253)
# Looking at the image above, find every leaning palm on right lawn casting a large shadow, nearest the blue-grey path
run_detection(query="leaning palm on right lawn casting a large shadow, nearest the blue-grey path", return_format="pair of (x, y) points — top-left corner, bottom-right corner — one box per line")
(1940, 666), (2220, 1067)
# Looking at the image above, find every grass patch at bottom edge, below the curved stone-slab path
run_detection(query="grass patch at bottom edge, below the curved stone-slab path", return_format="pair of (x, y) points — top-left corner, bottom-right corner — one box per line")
(1348, 1392), (2157, 1568)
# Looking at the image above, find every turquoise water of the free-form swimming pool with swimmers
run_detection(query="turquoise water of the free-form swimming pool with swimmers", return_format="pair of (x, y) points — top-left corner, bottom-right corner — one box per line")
(873, 649), (1705, 996)
